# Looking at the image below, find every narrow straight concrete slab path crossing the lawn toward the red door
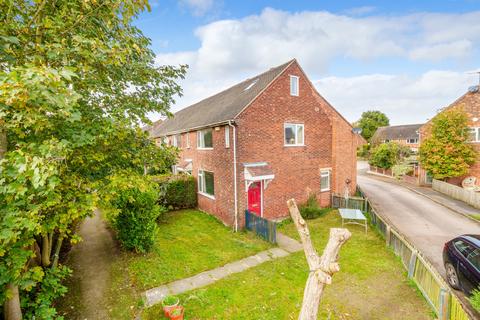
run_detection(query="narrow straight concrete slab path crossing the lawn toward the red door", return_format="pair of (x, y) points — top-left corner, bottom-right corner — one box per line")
(145, 232), (303, 307)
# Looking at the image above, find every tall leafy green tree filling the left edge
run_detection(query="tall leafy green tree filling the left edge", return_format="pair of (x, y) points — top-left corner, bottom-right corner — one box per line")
(0, 0), (186, 319)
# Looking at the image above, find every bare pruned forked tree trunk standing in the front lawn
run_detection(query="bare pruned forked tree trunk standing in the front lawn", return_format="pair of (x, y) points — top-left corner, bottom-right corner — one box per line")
(287, 199), (352, 320)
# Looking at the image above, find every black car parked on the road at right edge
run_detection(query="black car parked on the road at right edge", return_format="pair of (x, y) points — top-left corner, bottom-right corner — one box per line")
(443, 235), (480, 294)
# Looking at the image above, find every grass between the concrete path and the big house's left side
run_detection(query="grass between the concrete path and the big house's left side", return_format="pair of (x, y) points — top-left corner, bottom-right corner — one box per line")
(105, 210), (271, 319)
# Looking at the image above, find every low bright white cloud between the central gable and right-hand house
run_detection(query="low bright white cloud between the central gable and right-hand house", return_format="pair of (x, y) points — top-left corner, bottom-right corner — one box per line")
(314, 70), (475, 124)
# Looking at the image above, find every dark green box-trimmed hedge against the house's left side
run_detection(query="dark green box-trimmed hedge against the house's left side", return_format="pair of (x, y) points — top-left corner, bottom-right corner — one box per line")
(155, 174), (197, 209)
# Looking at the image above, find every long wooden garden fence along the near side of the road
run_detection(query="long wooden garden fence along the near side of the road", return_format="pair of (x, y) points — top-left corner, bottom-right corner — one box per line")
(342, 189), (474, 320)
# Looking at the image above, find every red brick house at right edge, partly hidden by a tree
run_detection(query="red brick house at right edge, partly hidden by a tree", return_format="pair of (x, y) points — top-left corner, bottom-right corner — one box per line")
(419, 86), (480, 186)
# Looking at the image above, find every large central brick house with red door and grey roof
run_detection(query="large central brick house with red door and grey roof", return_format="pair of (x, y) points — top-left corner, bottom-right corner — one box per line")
(151, 60), (359, 229)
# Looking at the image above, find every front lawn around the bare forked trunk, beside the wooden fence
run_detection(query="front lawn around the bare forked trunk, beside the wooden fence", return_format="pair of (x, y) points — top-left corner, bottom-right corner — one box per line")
(142, 211), (432, 320)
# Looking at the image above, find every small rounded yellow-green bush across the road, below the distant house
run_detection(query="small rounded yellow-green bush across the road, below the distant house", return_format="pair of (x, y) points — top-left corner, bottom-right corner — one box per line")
(369, 141), (411, 169)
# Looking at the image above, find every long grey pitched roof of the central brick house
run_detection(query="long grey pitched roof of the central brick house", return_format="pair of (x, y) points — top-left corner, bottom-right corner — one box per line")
(152, 60), (295, 137)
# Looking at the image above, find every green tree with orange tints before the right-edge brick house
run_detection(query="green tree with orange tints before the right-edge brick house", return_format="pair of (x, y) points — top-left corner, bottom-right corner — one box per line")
(419, 108), (477, 179)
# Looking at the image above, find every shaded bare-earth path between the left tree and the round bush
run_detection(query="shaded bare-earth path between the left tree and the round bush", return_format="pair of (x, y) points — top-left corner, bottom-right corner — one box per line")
(63, 210), (117, 320)
